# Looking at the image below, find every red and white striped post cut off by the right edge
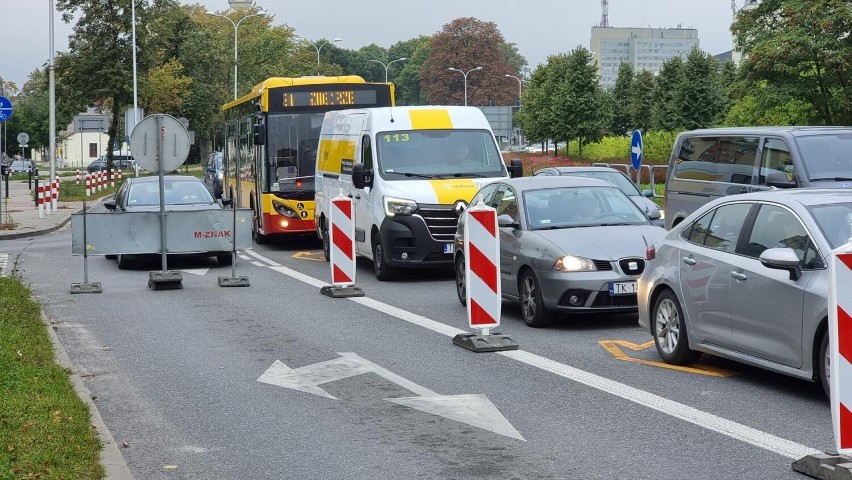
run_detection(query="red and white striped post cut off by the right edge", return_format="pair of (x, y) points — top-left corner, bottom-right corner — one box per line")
(828, 248), (852, 455)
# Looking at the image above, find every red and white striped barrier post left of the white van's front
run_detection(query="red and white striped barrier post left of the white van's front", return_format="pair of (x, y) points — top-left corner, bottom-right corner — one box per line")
(328, 195), (355, 287)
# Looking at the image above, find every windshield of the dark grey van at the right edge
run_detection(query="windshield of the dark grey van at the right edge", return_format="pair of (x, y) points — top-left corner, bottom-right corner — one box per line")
(796, 134), (852, 181)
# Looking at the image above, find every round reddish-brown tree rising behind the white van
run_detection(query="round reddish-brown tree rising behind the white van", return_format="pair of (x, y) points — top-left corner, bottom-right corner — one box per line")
(420, 17), (518, 105)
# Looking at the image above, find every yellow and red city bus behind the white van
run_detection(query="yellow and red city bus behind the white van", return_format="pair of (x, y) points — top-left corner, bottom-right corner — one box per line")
(222, 75), (394, 243)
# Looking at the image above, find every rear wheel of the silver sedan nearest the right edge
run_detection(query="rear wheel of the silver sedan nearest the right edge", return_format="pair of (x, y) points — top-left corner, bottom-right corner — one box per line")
(652, 290), (700, 365)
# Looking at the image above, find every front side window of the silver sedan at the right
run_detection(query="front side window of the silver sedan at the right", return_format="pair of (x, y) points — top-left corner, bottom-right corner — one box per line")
(746, 205), (821, 268)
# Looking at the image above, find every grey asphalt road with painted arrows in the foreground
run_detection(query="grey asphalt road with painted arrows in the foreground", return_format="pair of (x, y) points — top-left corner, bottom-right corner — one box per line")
(0, 230), (833, 479)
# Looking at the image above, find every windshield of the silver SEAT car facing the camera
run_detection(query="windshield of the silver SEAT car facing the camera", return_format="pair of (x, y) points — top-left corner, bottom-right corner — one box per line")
(523, 187), (648, 230)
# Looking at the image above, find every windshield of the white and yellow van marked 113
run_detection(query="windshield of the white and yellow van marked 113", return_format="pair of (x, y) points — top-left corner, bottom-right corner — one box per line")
(376, 129), (505, 180)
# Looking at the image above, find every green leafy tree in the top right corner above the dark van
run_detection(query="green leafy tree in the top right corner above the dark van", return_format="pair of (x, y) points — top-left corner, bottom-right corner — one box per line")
(731, 0), (852, 125)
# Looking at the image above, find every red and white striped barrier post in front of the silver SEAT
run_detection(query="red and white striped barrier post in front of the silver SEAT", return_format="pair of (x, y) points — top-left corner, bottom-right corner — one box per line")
(464, 202), (502, 335)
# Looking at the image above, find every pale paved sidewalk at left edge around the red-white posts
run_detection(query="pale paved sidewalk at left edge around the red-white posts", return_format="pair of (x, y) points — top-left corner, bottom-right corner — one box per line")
(0, 177), (100, 240)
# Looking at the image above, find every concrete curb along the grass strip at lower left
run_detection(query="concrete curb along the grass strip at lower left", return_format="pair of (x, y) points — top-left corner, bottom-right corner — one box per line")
(41, 312), (135, 480)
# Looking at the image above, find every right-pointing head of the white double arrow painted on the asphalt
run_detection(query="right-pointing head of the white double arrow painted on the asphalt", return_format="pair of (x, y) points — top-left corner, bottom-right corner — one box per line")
(386, 395), (526, 442)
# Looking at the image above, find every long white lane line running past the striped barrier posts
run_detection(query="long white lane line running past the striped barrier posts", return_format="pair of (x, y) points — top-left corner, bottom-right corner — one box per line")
(243, 252), (820, 460)
